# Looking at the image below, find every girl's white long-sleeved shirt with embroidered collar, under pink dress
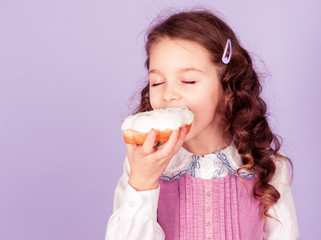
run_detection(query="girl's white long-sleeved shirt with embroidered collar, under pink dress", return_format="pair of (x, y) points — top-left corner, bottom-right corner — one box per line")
(105, 143), (299, 240)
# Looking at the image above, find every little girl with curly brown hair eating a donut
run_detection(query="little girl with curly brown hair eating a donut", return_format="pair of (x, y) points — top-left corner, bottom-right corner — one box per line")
(106, 8), (299, 240)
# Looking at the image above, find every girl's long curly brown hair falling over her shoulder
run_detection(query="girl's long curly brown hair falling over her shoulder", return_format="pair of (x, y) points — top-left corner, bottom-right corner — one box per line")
(135, 10), (292, 219)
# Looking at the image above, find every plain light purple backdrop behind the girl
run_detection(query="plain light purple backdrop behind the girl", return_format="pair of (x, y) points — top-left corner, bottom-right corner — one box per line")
(0, 0), (321, 240)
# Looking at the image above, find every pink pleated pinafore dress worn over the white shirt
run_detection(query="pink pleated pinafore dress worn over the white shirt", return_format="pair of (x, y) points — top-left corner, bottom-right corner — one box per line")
(157, 162), (264, 240)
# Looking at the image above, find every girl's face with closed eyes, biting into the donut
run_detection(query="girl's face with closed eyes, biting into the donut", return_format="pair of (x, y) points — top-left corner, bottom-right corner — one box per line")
(148, 38), (224, 150)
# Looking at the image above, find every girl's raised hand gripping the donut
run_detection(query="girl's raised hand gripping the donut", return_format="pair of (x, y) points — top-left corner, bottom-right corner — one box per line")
(127, 128), (187, 191)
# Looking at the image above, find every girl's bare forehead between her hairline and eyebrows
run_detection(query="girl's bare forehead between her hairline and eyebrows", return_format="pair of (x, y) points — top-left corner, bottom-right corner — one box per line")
(149, 37), (213, 71)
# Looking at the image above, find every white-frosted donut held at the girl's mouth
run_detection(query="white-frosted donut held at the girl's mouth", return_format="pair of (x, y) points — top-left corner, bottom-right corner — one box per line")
(121, 107), (194, 145)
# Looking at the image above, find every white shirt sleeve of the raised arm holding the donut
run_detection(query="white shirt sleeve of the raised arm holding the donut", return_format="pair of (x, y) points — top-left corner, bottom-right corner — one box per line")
(105, 157), (165, 240)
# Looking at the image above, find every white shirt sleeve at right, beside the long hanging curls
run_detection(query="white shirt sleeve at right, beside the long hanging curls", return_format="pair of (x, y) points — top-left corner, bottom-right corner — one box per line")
(264, 157), (299, 240)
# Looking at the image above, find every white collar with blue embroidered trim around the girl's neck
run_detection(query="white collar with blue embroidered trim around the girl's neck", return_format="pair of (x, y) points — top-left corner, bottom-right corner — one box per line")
(160, 142), (255, 181)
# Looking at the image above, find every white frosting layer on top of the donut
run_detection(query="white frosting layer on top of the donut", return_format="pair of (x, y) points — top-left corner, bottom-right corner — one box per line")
(121, 107), (194, 133)
